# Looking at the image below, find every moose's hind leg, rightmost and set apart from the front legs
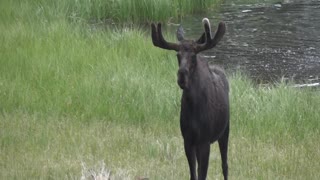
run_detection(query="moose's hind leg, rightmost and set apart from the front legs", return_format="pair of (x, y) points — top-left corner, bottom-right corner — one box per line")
(218, 124), (229, 180)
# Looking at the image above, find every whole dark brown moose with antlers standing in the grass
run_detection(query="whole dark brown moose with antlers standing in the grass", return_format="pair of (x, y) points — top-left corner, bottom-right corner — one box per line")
(151, 18), (230, 180)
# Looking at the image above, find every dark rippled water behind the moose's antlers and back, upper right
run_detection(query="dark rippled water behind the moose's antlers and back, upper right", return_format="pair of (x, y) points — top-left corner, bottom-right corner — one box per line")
(176, 0), (320, 83)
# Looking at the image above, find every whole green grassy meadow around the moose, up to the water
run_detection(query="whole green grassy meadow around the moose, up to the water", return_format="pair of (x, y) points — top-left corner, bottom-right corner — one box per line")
(0, 0), (320, 180)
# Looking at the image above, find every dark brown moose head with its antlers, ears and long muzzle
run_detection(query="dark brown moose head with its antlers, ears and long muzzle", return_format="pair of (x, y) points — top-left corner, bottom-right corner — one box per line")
(151, 18), (226, 89)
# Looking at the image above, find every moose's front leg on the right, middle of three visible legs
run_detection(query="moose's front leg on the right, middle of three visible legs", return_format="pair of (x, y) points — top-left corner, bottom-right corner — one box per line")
(196, 143), (210, 180)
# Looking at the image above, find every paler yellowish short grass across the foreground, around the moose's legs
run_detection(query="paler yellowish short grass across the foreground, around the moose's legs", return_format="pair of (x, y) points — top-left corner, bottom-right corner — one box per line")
(0, 109), (319, 180)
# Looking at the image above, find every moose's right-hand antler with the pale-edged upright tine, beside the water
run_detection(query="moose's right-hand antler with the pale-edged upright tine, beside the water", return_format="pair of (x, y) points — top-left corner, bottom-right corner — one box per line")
(196, 18), (226, 53)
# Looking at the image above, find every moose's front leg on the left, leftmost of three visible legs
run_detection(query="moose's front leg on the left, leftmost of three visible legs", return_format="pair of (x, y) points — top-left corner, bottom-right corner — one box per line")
(184, 142), (197, 180)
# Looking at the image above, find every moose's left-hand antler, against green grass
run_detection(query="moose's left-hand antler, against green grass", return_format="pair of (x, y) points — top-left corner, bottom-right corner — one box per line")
(151, 23), (179, 51)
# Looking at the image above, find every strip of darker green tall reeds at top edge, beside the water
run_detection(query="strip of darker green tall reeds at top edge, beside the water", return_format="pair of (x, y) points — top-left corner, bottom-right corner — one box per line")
(68, 0), (221, 23)
